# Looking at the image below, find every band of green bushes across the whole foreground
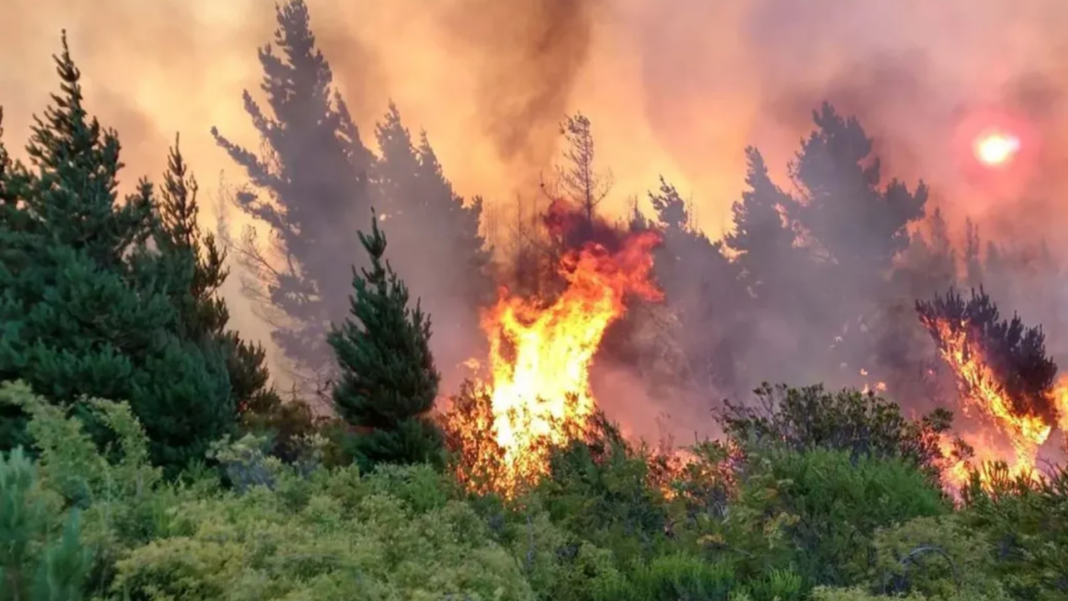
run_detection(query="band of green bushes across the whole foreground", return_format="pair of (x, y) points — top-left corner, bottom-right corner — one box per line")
(0, 383), (1068, 601)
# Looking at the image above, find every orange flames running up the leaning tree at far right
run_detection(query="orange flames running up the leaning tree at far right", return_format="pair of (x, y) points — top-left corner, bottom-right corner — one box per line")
(924, 319), (1053, 488)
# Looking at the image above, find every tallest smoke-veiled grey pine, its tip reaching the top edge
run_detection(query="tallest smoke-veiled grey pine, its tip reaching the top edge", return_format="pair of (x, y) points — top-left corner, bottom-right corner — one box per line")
(211, 0), (374, 394)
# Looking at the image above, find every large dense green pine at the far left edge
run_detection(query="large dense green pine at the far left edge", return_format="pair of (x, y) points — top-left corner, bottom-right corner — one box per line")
(0, 34), (234, 473)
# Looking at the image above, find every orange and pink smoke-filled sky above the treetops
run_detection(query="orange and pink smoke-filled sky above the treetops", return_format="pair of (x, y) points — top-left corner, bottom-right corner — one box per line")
(6, 0), (1068, 446)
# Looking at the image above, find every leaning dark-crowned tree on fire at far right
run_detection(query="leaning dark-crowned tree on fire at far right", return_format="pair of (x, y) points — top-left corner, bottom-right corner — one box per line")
(916, 288), (1057, 484)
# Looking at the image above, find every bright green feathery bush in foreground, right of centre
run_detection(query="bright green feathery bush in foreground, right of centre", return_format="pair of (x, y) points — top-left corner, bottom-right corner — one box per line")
(706, 448), (948, 586)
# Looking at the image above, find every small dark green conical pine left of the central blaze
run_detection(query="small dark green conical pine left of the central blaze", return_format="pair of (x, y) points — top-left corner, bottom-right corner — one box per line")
(328, 212), (444, 470)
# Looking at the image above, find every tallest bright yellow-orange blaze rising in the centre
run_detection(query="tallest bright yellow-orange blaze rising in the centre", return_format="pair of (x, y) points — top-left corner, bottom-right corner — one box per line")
(446, 203), (661, 495)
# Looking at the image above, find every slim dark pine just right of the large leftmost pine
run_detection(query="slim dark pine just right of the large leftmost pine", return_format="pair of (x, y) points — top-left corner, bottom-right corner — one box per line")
(156, 133), (312, 457)
